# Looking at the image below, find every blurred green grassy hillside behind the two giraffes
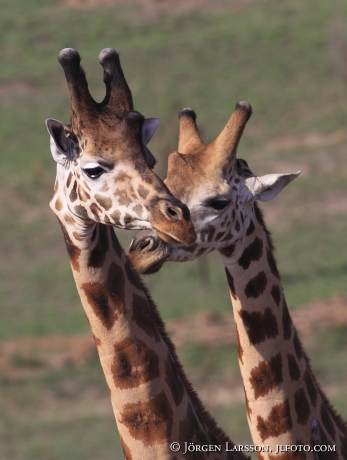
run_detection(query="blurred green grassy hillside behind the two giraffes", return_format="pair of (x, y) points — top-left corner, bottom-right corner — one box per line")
(0, 0), (347, 460)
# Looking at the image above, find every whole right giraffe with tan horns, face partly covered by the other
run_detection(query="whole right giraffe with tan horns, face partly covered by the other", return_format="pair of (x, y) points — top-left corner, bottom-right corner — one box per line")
(129, 101), (347, 460)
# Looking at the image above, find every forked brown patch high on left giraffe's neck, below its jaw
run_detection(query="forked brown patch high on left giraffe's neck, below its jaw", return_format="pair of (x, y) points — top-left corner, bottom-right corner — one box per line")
(81, 262), (126, 331)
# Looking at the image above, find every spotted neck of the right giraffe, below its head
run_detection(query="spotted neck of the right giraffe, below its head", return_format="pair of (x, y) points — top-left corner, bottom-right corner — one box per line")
(221, 207), (347, 460)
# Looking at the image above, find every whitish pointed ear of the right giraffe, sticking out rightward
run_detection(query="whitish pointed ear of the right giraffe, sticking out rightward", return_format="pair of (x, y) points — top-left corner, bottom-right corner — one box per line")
(245, 171), (301, 201)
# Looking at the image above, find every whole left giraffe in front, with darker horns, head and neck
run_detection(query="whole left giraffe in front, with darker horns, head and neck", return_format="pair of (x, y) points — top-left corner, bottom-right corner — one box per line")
(46, 48), (250, 460)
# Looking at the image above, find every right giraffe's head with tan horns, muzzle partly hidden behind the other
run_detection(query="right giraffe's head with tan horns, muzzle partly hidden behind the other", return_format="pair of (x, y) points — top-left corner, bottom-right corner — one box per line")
(129, 102), (299, 273)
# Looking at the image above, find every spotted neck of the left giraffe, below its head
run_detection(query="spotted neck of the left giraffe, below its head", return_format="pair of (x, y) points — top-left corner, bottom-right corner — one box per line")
(57, 220), (246, 460)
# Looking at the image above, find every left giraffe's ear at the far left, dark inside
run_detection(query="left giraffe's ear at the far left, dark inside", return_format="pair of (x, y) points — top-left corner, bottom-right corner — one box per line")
(46, 118), (79, 164)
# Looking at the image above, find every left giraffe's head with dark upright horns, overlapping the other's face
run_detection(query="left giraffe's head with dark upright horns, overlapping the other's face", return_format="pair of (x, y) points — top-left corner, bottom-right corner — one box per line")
(46, 48), (195, 244)
